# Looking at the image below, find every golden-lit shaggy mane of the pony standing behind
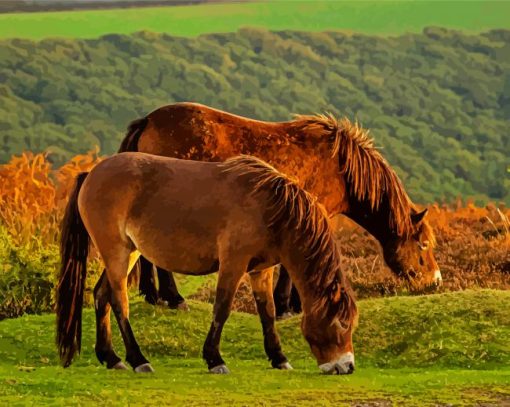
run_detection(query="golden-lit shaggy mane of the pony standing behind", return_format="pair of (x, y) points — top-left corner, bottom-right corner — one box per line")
(293, 114), (435, 242)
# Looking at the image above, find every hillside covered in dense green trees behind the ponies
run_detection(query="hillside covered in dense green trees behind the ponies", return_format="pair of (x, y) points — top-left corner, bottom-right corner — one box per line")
(0, 28), (510, 204)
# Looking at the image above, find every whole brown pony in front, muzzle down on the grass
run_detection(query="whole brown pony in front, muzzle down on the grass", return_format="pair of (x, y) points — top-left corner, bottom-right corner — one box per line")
(57, 153), (357, 374)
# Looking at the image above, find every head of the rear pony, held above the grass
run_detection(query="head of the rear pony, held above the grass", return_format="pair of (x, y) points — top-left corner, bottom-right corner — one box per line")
(383, 209), (442, 287)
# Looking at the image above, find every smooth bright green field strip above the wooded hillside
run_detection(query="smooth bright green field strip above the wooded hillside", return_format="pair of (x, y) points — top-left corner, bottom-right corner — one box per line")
(0, 0), (510, 39)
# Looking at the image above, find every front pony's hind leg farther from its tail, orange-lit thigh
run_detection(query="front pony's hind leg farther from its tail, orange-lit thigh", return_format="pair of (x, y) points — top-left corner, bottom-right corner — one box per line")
(103, 247), (154, 373)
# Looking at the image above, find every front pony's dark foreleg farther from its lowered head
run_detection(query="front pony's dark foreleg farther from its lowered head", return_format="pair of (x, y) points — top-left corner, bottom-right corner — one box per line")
(202, 262), (246, 373)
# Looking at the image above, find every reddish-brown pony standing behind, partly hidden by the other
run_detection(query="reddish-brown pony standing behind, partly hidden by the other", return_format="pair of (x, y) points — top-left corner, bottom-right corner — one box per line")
(119, 103), (441, 314)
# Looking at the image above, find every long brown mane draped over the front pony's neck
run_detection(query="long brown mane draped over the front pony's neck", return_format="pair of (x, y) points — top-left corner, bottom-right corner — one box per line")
(221, 155), (357, 326)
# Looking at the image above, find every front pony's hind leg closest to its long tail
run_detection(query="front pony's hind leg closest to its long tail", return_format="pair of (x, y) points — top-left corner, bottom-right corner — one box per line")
(94, 270), (127, 369)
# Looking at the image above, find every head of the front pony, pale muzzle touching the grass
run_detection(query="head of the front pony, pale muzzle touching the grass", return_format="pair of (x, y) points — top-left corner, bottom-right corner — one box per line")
(301, 279), (357, 374)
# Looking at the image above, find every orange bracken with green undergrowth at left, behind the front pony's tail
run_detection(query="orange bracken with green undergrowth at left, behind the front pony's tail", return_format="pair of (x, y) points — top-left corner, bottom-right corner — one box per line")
(0, 152), (100, 320)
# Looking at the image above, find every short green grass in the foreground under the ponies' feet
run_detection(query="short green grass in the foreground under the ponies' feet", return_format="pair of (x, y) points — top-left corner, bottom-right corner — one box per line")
(0, 290), (510, 406)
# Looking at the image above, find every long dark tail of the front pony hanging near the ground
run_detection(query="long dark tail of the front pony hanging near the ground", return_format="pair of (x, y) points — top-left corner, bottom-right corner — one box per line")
(56, 172), (90, 367)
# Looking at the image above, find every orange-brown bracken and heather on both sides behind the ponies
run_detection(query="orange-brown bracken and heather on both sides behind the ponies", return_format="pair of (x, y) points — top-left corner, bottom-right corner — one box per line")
(0, 151), (510, 318)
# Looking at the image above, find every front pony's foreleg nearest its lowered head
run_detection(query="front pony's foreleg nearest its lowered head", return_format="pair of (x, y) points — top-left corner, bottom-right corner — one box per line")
(250, 267), (292, 370)
